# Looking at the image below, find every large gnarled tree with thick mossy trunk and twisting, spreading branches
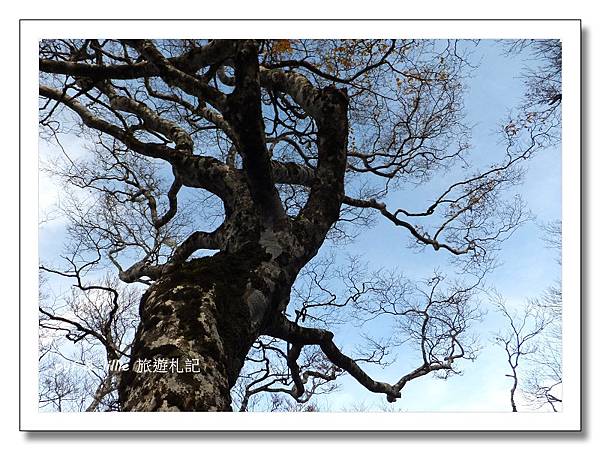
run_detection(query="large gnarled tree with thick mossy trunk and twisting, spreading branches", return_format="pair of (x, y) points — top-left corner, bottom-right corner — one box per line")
(39, 39), (556, 411)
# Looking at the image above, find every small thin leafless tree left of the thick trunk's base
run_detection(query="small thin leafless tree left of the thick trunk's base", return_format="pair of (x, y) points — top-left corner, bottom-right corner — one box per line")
(39, 266), (140, 411)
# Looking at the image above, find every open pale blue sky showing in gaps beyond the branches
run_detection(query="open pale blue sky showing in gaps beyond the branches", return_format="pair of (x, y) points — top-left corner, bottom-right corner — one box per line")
(39, 41), (561, 411)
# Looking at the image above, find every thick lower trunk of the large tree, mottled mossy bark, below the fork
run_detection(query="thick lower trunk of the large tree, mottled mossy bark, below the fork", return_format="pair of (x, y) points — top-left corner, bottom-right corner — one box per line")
(119, 248), (264, 411)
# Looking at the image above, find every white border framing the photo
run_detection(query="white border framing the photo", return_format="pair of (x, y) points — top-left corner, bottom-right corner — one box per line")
(19, 19), (582, 431)
